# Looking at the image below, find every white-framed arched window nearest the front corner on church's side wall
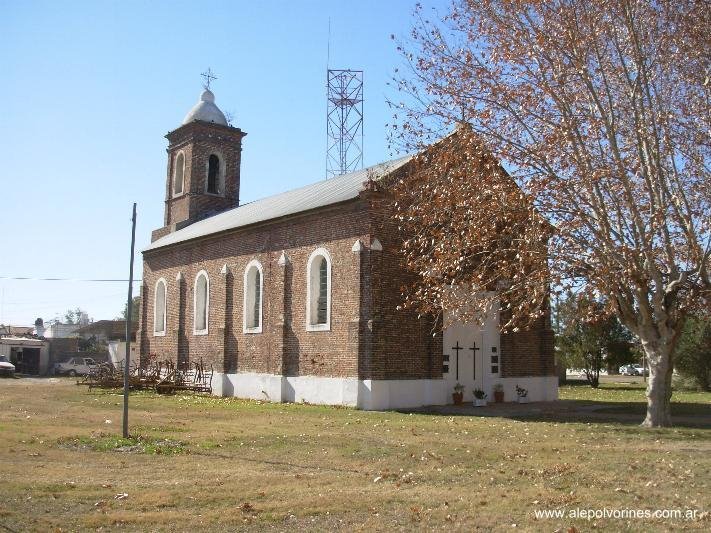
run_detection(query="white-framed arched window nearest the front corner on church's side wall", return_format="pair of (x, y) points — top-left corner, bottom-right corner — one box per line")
(306, 248), (331, 331)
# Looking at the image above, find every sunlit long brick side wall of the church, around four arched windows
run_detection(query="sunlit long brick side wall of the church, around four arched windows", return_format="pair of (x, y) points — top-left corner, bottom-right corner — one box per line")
(141, 201), (368, 376)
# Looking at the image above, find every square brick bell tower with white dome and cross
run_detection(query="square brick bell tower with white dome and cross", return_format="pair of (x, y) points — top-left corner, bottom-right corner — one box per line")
(152, 76), (246, 241)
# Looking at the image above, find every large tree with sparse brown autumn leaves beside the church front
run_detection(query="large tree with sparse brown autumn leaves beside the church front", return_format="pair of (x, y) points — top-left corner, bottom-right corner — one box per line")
(394, 0), (711, 426)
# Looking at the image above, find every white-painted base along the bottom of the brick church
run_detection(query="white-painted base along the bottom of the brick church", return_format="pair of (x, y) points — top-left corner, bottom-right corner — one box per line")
(212, 373), (558, 411)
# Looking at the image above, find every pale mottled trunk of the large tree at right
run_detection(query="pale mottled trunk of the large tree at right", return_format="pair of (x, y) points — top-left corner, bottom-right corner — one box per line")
(642, 341), (672, 427)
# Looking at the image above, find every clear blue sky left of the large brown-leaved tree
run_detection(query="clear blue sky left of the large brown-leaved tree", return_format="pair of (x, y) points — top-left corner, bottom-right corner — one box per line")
(0, 0), (446, 324)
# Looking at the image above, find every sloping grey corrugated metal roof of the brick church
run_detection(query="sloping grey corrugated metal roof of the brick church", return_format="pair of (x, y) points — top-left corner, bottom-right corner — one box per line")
(144, 156), (412, 251)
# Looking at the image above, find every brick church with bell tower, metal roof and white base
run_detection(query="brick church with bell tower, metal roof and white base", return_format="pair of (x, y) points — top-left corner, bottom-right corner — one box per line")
(139, 90), (558, 409)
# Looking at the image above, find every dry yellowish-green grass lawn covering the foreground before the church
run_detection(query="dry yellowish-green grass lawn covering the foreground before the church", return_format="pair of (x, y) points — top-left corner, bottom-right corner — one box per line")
(0, 379), (711, 531)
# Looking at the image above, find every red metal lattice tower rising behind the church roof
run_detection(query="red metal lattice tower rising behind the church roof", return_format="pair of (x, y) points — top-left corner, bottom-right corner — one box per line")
(326, 69), (363, 178)
